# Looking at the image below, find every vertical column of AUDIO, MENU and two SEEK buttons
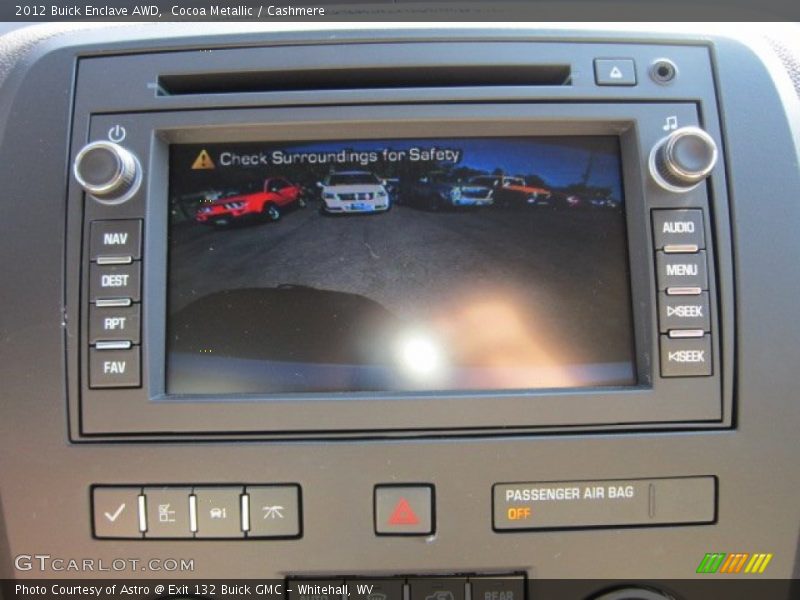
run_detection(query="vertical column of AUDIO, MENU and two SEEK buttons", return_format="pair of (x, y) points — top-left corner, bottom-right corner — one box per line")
(653, 209), (712, 377)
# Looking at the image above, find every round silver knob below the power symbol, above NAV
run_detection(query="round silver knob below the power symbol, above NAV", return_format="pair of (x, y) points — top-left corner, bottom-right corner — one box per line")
(72, 141), (142, 204)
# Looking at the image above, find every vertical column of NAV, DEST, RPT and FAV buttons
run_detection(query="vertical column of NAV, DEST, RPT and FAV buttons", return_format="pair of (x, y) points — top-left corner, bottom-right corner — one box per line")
(89, 219), (142, 388)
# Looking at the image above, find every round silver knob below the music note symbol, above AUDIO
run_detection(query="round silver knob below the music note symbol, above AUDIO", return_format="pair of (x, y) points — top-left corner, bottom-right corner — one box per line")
(650, 127), (717, 192)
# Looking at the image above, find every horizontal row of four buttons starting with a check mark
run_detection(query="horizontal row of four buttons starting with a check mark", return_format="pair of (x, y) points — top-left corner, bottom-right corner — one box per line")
(92, 484), (302, 539)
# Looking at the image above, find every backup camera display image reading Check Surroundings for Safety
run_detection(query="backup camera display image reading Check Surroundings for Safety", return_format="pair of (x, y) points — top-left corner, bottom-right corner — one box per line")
(167, 136), (636, 394)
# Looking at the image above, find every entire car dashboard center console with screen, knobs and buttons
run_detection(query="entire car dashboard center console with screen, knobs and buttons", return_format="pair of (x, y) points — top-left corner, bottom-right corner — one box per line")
(0, 23), (800, 600)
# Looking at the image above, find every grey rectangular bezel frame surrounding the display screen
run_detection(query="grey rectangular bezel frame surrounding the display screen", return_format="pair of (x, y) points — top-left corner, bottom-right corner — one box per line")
(75, 103), (722, 436)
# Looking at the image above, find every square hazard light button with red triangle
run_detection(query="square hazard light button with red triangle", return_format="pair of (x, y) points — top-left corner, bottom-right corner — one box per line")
(375, 485), (434, 535)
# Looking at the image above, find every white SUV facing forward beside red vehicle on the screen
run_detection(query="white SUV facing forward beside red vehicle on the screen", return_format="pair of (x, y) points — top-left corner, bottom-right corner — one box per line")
(317, 171), (391, 213)
